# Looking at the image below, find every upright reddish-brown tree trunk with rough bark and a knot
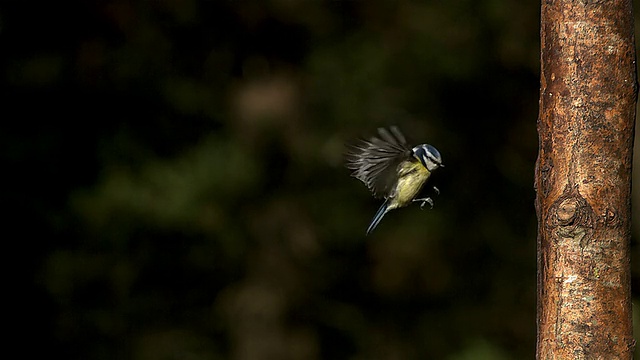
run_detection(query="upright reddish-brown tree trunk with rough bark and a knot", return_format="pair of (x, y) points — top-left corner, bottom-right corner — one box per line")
(535, 0), (637, 360)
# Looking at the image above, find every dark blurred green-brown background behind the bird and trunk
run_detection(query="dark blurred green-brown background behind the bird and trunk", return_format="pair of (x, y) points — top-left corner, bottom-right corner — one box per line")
(0, 0), (640, 360)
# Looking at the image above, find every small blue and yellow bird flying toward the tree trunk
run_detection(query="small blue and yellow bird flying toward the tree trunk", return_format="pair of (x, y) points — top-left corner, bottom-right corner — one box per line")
(346, 126), (444, 235)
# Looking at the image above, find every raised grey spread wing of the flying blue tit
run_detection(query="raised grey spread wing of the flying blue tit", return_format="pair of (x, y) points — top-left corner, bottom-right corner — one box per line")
(346, 126), (411, 198)
